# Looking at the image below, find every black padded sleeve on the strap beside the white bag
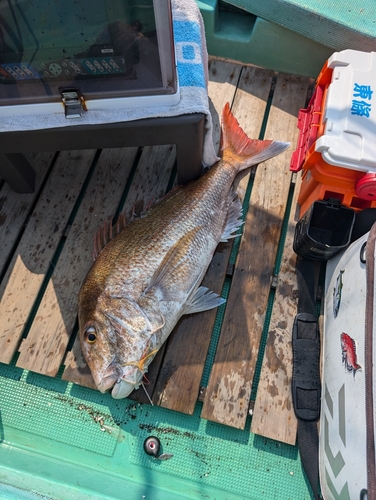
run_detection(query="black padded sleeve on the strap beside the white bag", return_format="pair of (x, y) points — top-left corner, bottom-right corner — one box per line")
(291, 313), (321, 421)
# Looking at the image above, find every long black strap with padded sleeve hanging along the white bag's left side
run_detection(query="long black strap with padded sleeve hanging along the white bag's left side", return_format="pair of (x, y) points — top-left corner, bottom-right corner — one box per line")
(292, 257), (321, 500)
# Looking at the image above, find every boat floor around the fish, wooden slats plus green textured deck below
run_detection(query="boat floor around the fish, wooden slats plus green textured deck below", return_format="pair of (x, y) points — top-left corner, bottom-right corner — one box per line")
(0, 60), (318, 500)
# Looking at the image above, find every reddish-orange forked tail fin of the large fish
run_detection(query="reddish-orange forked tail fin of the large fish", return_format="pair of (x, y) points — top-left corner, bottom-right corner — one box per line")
(221, 103), (290, 170)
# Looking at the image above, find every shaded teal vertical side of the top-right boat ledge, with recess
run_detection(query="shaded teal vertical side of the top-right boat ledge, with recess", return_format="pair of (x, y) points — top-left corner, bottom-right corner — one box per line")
(196, 0), (333, 78)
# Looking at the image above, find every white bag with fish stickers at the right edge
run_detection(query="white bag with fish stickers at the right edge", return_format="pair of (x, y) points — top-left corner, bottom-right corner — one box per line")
(319, 224), (376, 500)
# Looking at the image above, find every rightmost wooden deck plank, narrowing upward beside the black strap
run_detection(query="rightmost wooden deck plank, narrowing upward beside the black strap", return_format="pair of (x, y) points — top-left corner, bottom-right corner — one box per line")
(251, 176), (301, 445)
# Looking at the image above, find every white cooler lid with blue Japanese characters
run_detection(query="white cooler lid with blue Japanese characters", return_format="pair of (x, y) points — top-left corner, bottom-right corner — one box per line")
(315, 50), (376, 172)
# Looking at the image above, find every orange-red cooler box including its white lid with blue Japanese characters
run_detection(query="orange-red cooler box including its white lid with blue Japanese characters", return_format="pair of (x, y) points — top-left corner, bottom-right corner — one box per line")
(290, 50), (376, 216)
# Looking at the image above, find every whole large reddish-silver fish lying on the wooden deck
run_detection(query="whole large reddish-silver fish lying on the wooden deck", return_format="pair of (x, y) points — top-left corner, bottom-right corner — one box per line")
(78, 104), (289, 398)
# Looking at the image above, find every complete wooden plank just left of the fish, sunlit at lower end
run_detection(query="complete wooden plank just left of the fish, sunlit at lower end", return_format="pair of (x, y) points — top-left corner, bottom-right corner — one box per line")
(17, 148), (137, 376)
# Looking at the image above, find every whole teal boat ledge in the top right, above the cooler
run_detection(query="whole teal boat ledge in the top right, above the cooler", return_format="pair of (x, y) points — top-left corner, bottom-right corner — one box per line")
(196, 0), (376, 78)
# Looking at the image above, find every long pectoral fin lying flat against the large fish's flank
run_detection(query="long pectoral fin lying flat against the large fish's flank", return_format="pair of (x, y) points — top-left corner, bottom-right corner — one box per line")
(142, 226), (202, 300)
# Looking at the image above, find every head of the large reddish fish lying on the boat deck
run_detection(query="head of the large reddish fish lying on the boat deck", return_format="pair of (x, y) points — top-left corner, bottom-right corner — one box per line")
(78, 290), (163, 399)
